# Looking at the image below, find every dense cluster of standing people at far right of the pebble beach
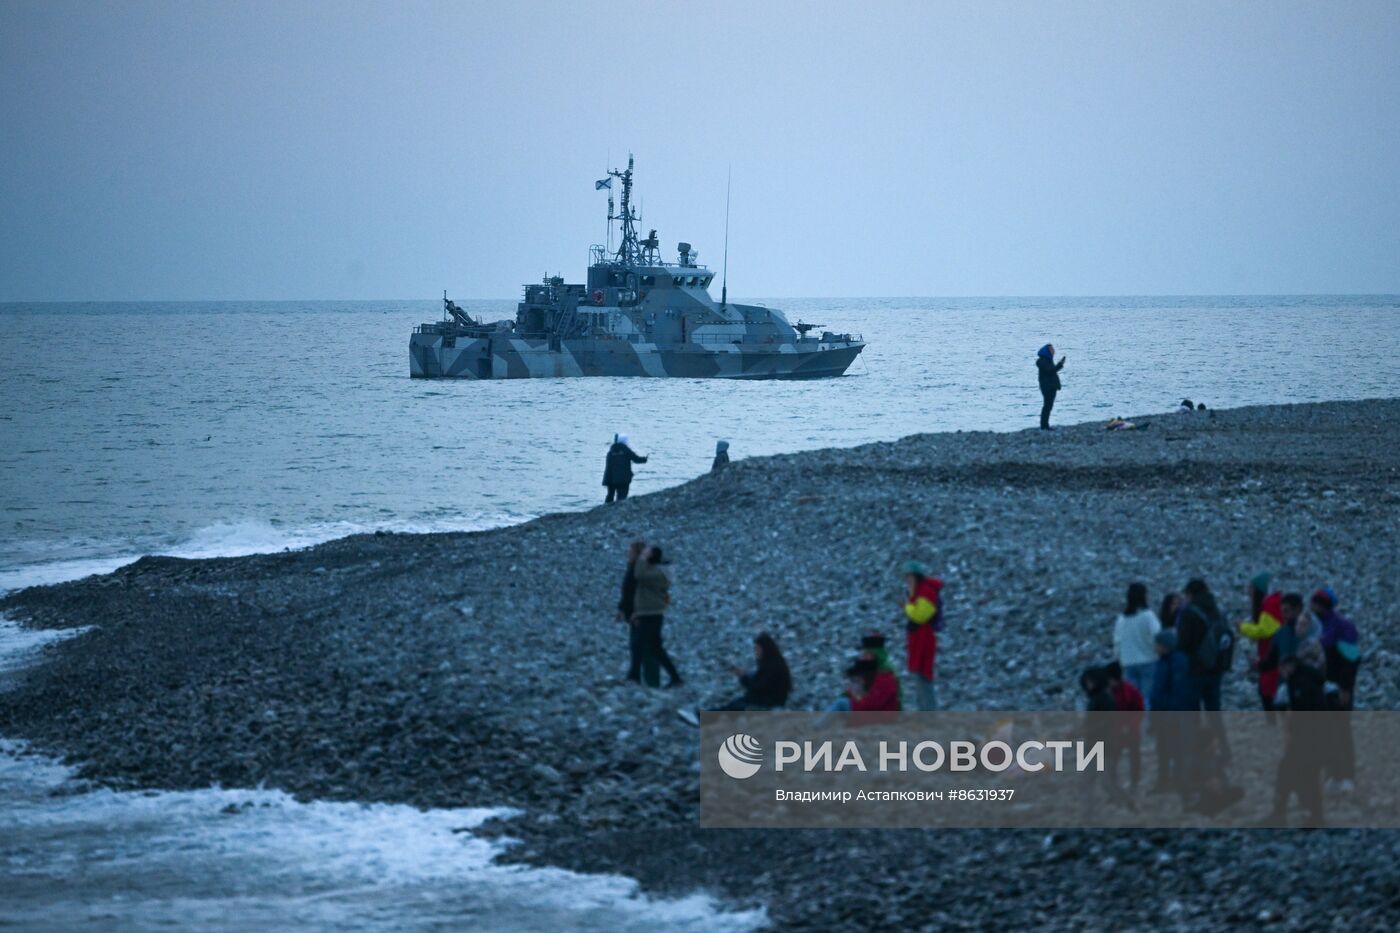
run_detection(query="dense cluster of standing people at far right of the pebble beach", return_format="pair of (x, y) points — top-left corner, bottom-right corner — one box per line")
(1097, 573), (1361, 825)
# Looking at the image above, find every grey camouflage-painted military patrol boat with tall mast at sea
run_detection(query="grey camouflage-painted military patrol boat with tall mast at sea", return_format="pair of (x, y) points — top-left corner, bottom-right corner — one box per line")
(409, 157), (865, 380)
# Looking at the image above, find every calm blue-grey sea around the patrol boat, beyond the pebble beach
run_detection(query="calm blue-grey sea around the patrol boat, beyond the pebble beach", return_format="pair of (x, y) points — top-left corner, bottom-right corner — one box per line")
(8, 296), (1400, 588)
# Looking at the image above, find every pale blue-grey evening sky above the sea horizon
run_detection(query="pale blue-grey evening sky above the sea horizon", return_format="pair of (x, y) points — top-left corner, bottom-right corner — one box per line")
(0, 0), (1400, 300)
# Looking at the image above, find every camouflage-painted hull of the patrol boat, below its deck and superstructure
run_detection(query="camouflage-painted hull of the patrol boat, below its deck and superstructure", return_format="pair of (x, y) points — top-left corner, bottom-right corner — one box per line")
(409, 333), (864, 380)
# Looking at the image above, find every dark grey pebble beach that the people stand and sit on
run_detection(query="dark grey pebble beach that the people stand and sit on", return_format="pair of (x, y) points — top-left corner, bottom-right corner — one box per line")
(0, 399), (1400, 929)
